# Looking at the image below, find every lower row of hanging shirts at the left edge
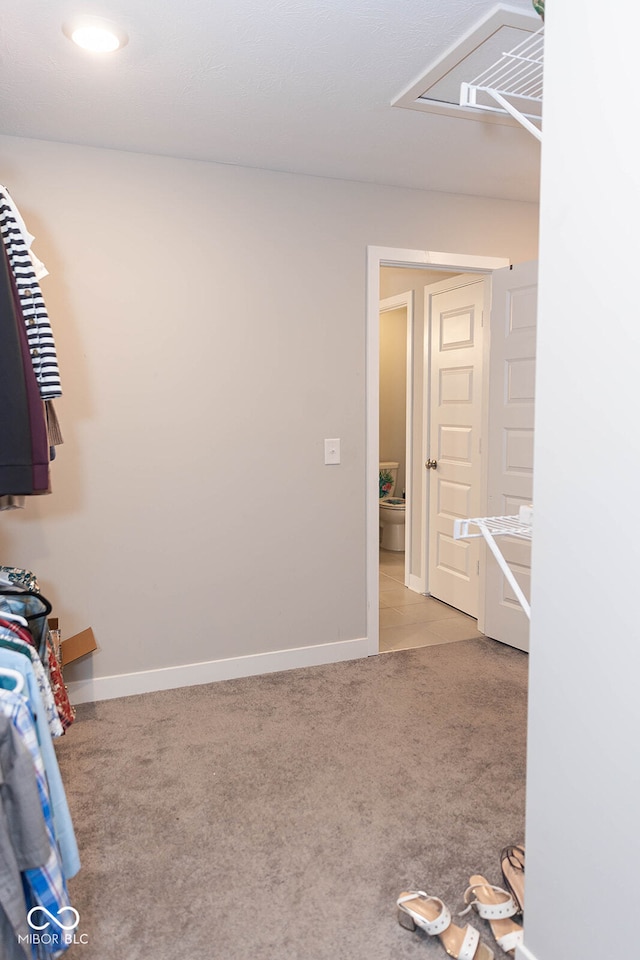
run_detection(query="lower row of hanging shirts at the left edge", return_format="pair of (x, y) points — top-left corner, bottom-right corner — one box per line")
(0, 566), (80, 960)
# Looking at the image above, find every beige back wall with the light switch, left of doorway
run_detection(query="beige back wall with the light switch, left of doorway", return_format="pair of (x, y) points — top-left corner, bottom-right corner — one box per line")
(0, 138), (538, 696)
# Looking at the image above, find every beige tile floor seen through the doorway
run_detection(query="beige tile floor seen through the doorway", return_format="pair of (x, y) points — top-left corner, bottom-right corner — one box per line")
(380, 549), (482, 653)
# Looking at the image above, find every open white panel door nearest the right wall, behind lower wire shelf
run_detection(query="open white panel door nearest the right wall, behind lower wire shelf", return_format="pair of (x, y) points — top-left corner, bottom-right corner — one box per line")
(482, 261), (538, 650)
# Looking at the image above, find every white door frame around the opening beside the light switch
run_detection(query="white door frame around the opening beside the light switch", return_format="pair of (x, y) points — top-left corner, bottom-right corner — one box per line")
(365, 246), (511, 656)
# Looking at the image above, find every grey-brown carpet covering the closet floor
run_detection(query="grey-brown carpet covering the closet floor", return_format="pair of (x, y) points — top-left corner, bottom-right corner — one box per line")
(58, 638), (527, 960)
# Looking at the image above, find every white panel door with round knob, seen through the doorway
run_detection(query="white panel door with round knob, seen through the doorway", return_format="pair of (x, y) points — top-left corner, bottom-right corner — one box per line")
(425, 274), (488, 617)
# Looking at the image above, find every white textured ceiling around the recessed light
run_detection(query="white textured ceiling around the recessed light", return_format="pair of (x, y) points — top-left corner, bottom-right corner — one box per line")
(0, 0), (540, 201)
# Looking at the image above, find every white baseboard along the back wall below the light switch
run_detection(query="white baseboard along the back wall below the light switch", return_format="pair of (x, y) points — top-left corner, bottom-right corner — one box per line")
(67, 637), (368, 704)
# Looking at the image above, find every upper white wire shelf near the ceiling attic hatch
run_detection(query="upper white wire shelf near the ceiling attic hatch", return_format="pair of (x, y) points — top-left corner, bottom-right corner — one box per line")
(460, 27), (544, 140)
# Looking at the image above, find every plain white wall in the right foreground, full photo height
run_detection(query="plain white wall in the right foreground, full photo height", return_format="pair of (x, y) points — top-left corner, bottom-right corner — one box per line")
(522, 0), (640, 960)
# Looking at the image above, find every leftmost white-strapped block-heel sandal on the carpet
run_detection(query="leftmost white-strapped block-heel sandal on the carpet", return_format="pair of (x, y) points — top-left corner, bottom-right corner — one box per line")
(397, 890), (494, 960)
